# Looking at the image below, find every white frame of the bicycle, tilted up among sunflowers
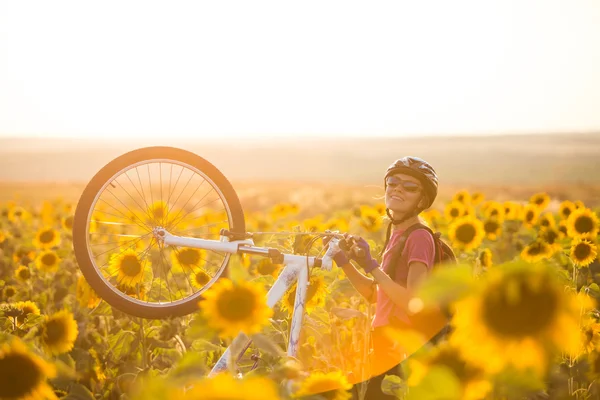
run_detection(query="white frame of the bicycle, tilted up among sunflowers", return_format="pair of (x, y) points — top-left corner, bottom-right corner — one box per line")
(155, 228), (338, 377)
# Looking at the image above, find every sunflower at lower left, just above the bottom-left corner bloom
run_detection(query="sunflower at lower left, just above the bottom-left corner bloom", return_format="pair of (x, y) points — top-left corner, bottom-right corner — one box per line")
(41, 310), (79, 355)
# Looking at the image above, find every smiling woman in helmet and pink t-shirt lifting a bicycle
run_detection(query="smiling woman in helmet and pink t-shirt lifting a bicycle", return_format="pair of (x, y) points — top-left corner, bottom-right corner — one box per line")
(334, 157), (438, 399)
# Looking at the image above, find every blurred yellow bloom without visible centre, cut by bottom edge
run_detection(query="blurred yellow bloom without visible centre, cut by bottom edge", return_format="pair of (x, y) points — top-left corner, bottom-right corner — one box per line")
(184, 372), (280, 400)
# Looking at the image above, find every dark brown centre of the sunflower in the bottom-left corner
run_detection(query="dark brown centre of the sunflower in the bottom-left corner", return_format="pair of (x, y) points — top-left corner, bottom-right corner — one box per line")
(0, 353), (43, 399)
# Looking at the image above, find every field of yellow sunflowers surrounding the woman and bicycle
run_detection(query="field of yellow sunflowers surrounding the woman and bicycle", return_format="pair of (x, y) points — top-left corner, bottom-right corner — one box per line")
(0, 190), (600, 400)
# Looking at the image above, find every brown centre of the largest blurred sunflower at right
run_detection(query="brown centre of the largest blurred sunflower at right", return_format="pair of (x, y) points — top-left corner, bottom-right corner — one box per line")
(482, 277), (558, 338)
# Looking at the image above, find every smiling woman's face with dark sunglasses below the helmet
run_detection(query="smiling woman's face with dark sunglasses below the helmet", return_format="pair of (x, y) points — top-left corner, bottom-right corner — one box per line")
(385, 173), (423, 215)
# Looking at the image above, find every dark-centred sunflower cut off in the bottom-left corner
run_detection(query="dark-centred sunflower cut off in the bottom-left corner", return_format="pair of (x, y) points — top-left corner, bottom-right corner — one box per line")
(0, 339), (57, 400)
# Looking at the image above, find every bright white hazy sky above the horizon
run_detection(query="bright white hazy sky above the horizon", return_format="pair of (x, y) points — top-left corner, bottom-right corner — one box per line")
(0, 0), (600, 140)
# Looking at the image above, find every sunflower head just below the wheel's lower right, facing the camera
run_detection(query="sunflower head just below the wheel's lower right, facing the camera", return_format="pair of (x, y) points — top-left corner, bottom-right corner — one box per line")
(199, 278), (273, 338)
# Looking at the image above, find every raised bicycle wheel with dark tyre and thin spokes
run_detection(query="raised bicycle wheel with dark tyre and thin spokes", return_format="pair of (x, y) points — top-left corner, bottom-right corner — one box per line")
(73, 147), (245, 319)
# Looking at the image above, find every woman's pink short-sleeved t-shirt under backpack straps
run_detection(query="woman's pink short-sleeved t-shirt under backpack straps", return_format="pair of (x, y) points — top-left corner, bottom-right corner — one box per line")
(372, 229), (435, 328)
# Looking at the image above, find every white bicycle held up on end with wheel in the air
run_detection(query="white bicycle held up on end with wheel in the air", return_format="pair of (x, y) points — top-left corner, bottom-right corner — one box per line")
(73, 147), (360, 376)
